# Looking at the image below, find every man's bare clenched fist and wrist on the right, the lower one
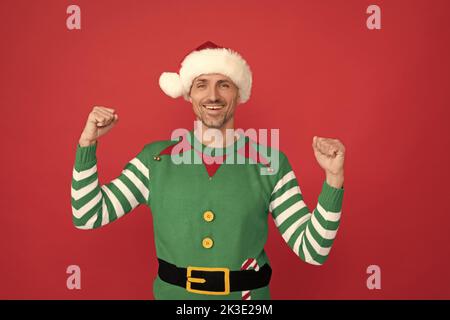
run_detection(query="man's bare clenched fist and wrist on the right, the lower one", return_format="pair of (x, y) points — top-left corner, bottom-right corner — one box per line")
(312, 136), (345, 188)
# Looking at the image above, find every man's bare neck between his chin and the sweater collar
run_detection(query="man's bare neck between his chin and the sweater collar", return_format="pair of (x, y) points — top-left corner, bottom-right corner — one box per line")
(194, 118), (237, 148)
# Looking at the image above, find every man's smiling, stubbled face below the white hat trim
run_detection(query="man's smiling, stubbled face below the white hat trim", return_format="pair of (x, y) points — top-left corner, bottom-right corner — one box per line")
(189, 73), (239, 129)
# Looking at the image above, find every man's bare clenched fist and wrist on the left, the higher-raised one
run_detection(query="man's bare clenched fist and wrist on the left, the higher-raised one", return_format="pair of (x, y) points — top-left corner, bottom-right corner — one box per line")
(79, 106), (119, 147)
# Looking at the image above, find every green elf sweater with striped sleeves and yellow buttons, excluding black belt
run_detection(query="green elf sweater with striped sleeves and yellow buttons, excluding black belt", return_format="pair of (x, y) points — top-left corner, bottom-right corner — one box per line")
(72, 131), (343, 299)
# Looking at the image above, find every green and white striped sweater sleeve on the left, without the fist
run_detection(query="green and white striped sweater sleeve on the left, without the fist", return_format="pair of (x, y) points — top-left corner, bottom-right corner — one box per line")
(71, 143), (149, 229)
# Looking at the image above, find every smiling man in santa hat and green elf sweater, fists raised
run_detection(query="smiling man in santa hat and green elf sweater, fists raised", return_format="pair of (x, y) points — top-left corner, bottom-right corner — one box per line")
(72, 42), (345, 299)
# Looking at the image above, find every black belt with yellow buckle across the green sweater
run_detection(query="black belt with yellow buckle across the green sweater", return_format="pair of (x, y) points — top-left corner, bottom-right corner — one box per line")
(158, 259), (272, 295)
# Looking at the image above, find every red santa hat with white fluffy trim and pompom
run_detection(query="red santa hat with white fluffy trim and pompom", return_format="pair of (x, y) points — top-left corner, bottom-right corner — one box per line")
(159, 41), (252, 103)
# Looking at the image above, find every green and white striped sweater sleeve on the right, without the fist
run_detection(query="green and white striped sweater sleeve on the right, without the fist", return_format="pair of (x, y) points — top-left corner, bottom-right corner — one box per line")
(269, 156), (344, 265)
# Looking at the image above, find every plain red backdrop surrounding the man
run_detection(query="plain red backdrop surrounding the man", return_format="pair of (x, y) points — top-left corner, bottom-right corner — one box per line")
(0, 0), (450, 299)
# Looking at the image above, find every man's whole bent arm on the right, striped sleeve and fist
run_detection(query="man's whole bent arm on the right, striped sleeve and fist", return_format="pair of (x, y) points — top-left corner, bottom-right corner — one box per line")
(269, 137), (345, 265)
